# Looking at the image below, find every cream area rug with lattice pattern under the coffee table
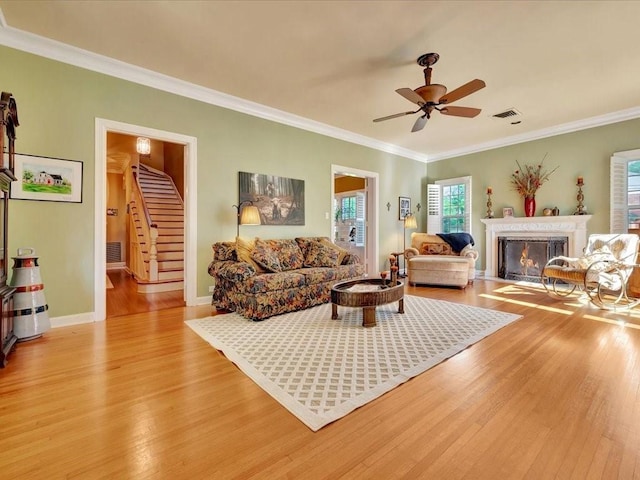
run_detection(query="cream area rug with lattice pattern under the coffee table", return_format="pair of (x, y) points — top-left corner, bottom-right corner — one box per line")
(185, 295), (521, 431)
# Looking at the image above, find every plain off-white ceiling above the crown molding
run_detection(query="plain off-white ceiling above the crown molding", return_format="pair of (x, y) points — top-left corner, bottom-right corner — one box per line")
(0, 0), (640, 160)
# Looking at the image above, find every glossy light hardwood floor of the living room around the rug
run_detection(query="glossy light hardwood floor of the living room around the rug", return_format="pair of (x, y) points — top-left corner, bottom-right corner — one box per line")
(0, 280), (640, 480)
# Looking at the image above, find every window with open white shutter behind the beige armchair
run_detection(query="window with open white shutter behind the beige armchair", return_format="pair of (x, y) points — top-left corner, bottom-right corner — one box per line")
(427, 177), (471, 234)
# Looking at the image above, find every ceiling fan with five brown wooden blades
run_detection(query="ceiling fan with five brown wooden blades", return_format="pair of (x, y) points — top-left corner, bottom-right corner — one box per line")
(374, 53), (486, 132)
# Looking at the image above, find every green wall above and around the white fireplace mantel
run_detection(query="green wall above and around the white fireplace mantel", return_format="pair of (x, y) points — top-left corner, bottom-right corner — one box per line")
(423, 119), (640, 269)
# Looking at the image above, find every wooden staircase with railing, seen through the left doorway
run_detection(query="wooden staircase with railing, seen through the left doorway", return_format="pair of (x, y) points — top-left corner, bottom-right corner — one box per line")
(130, 164), (184, 293)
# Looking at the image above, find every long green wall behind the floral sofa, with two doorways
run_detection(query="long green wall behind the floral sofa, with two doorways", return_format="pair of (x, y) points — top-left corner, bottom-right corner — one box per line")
(0, 47), (426, 317)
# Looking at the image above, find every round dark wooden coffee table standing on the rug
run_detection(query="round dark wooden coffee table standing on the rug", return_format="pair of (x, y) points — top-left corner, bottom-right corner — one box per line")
(331, 278), (404, 327)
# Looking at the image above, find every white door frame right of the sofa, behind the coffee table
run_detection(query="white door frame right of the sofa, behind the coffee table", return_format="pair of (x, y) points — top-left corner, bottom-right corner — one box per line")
(329, 165), (380, 276)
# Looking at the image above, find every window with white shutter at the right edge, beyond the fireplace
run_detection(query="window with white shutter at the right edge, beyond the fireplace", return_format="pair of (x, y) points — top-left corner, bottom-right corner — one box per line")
(609, 150), (640, 233)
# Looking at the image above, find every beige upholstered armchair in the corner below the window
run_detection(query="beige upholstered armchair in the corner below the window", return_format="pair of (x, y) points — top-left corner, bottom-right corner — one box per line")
(404, 232), (478, 288)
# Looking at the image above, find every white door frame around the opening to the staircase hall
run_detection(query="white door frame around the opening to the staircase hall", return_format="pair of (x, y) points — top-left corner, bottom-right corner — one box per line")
(93, 118), (198, 322)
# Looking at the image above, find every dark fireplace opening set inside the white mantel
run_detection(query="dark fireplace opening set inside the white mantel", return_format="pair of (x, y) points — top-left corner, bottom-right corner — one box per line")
(498, 237), (569, 282)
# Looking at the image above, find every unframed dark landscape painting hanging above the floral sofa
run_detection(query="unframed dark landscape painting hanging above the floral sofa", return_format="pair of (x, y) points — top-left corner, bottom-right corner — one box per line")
(238, 172), (304, 225)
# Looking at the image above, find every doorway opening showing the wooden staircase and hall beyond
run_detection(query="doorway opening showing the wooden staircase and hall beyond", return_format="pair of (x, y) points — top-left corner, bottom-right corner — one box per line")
(106, 132), (184, 318)
